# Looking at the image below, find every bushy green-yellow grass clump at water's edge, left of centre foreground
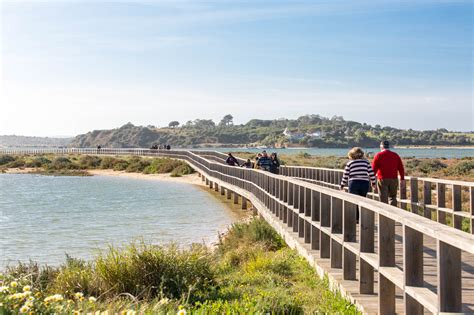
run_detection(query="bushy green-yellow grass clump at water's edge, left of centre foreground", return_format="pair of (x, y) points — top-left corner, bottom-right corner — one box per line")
(96, 243), (214, 301)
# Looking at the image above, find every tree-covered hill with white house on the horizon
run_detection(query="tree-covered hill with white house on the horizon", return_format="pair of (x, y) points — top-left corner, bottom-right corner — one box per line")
(70, 115), (474, 148)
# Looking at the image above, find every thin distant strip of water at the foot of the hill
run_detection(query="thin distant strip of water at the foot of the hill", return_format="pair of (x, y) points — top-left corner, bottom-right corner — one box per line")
(215, 148), (474, 159)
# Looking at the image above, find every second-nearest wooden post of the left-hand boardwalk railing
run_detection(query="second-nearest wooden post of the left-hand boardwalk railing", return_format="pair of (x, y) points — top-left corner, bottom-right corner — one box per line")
(403, 225), (423, 314)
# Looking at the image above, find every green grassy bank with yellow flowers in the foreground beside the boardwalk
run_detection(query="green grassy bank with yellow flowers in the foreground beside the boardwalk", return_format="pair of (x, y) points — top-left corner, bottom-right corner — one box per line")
(0, 219), (357, 314)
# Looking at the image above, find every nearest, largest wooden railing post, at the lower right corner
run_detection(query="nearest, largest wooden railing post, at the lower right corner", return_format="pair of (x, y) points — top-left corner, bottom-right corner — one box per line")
(437, 240), (462, 312)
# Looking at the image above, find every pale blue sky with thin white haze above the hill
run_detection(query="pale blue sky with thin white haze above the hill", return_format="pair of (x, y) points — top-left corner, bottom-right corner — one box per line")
(0, 0), (474, 136)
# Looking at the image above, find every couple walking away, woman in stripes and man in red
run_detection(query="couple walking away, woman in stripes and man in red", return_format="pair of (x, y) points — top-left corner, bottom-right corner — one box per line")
(340, 140), (405, 206)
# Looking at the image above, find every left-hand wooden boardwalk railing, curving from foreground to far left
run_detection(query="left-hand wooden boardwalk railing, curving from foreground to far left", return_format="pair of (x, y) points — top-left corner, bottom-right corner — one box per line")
(0, 149), (474, 314)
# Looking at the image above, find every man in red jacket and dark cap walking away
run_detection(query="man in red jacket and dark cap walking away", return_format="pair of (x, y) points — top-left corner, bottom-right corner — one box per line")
(372, 140), (405, 206)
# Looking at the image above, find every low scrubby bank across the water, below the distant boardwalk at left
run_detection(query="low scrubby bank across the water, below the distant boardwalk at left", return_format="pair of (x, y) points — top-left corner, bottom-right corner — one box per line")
(0, 155), (194, 177)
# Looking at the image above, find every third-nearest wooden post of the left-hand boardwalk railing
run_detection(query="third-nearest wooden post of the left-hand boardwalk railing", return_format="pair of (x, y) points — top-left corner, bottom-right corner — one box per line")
(378, 214), (395, 314)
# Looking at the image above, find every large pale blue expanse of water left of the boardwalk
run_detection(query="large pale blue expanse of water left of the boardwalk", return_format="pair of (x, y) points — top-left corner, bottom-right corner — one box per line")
(0, 174), (238, 269)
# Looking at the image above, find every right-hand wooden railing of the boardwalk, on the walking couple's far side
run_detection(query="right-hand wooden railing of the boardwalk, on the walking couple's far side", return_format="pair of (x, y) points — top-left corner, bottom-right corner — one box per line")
(194, 151), (474, 234)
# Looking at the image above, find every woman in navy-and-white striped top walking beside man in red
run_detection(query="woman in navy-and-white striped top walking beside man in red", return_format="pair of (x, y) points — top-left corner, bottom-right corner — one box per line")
(341, 147), (375, 197)
